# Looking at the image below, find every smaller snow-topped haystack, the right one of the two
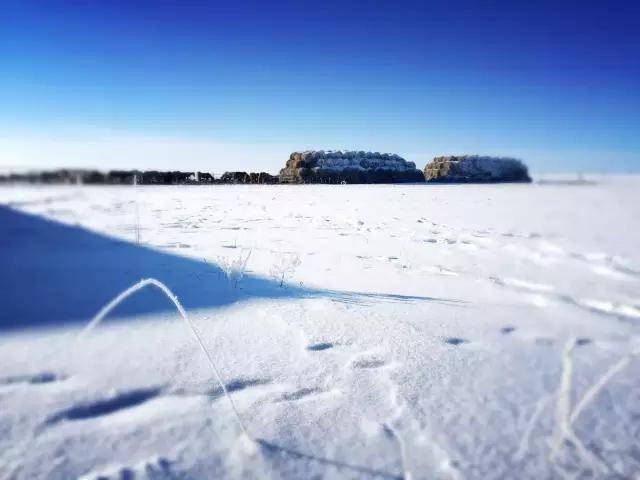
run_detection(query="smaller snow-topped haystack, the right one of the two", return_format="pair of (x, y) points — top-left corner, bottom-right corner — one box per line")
(424, 155), (531, 183)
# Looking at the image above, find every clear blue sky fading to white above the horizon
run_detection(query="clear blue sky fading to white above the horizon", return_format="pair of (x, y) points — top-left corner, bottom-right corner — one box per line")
(0, 0), (640, 172)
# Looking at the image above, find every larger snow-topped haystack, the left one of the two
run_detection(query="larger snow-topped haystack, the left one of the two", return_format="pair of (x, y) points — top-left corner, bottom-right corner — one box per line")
(280, 150), (424, 183)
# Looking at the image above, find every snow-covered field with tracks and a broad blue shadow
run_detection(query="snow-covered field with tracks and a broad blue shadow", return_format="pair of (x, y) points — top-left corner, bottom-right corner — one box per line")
(0, 177), (640, 479)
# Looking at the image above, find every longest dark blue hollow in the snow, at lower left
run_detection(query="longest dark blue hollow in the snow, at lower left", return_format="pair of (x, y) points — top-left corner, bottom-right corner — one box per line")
(46, 387), (162, 425)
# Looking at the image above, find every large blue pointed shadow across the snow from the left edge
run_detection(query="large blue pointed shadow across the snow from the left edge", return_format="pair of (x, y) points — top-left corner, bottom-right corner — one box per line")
(0, 206), (461, 330)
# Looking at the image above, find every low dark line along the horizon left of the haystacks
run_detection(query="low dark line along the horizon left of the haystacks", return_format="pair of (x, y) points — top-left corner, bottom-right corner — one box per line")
(0, 169), (278, 185)
